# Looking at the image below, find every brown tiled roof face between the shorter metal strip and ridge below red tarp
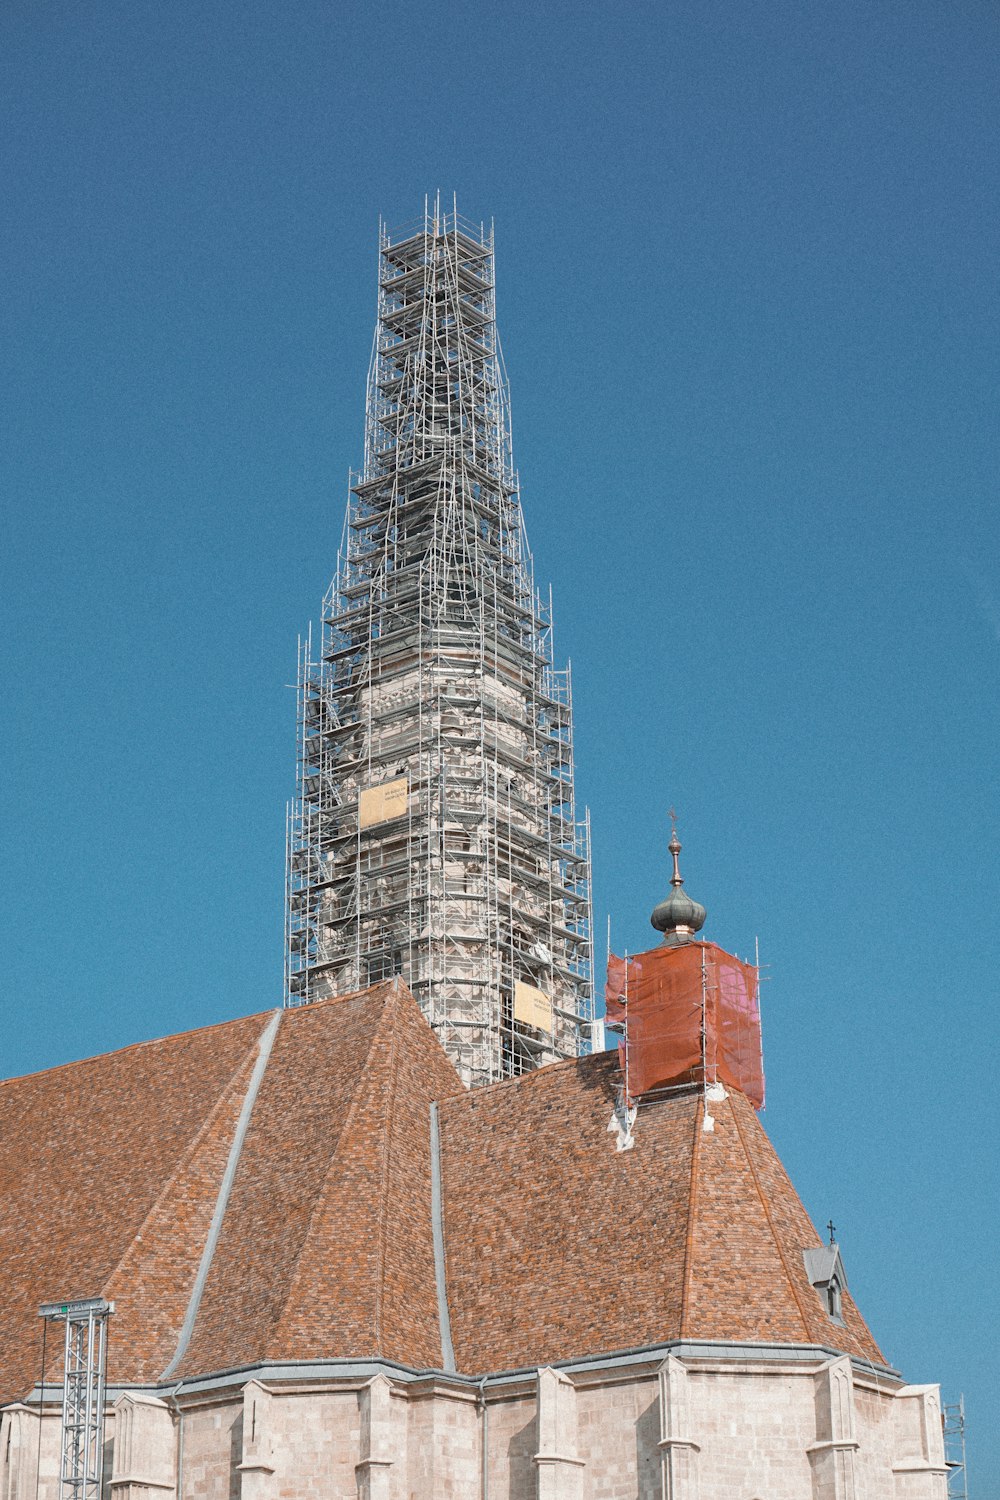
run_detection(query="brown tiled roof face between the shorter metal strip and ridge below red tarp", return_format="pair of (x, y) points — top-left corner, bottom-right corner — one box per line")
(441, 1055), (694, 1371)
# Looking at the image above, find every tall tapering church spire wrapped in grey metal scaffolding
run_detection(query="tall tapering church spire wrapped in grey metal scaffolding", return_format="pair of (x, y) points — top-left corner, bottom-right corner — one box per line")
(285, 203), (594, 1085)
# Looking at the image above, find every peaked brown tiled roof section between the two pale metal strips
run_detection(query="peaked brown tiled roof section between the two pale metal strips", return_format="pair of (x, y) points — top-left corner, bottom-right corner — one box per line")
(181, 983), (460, 1374)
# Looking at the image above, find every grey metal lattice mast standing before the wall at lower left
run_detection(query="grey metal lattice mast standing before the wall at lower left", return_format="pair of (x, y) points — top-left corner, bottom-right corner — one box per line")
(39, 1298), (114, 1500)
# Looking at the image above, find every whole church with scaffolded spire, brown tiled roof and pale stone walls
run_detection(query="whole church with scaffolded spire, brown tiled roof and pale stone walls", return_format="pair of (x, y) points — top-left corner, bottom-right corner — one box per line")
(0, 204), (948, 1500)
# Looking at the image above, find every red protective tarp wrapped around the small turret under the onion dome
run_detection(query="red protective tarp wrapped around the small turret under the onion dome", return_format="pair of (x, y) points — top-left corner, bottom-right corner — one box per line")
(604, 942), (765, 1109)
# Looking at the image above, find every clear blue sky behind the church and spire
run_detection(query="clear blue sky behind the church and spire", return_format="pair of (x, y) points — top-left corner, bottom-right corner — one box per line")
(0, 0), (1000, 1476)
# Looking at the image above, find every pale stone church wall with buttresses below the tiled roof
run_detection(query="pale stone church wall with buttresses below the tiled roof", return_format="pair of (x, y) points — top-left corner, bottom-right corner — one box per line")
(0, 1346), (948, 1500)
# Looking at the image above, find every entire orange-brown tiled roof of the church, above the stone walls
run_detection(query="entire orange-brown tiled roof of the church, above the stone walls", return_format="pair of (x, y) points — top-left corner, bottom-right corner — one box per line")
(0, 983), (882, 1403)
